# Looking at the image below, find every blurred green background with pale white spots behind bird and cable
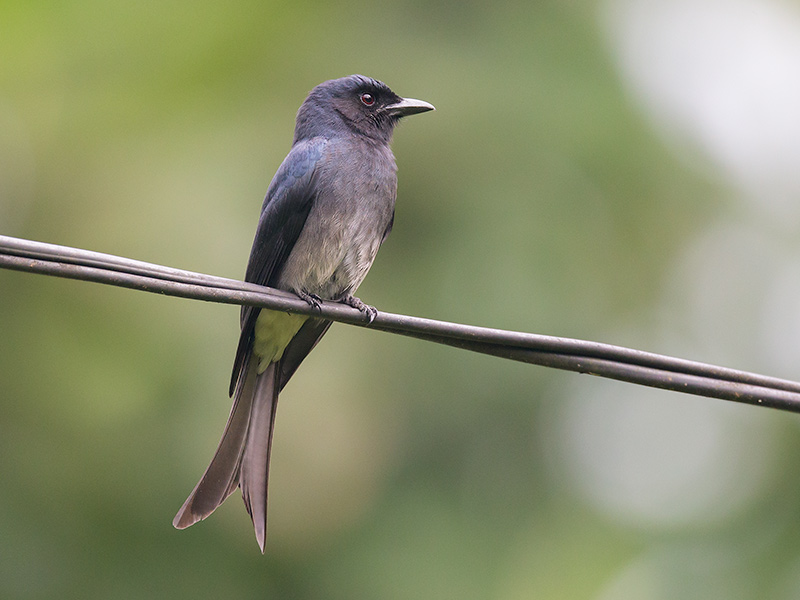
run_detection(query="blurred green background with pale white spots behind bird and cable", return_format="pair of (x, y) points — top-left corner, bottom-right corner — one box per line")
(0, 0), (800, 600)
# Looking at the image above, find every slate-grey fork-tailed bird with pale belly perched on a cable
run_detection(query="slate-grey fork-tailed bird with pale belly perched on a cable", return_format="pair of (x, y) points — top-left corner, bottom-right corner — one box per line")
(173, 75), (434, 554)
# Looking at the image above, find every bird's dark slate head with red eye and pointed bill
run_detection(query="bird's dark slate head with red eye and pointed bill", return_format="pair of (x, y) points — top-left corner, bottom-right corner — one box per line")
(294, 75), (434, 143)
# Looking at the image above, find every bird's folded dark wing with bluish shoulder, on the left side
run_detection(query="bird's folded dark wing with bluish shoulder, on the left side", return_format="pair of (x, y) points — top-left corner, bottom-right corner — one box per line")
(230, 137), (328, 395)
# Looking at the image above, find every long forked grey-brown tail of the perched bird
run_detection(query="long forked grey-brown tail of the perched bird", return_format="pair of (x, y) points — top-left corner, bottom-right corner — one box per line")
(172, 356), (280, 553)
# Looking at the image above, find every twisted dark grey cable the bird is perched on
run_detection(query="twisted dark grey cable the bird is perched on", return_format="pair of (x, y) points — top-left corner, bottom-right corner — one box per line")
(0, 236), (800, 412)
